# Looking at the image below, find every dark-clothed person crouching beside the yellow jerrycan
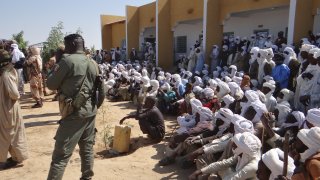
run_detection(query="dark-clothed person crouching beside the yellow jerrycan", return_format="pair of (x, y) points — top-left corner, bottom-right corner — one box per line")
(120, 96), (165, 141)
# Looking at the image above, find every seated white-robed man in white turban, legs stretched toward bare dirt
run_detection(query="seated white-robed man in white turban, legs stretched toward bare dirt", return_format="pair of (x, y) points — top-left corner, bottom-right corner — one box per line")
(189, 132), (261, 180)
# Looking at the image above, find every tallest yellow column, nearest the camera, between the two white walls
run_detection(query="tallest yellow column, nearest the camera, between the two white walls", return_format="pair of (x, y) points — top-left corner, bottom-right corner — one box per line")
(203, 0), (223, 67)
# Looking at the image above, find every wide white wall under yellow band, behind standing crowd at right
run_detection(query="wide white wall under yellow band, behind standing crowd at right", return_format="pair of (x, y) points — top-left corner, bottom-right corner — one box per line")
(223, 7), (289, 39)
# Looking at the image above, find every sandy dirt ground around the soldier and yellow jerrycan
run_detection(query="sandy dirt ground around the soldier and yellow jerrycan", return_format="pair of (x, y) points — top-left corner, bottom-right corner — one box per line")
(0, 85), (193, 180)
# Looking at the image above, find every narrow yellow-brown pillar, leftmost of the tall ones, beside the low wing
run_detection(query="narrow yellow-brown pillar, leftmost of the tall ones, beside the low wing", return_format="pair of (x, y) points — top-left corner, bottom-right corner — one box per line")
(126, 6), (139, 55)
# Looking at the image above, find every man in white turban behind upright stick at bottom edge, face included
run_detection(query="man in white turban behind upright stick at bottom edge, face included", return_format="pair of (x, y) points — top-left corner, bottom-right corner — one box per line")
(257, 148), (296, 180)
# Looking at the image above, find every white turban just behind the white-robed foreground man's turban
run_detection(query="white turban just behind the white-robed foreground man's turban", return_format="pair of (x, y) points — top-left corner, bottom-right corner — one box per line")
(231, 114), (254, 134)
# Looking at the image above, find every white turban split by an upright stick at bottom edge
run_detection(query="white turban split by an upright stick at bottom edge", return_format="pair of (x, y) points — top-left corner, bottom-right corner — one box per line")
(262, 148), (295, 180)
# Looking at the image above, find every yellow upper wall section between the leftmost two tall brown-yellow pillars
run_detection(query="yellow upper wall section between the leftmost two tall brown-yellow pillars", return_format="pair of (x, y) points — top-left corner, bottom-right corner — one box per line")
(139, 2), (156, 32)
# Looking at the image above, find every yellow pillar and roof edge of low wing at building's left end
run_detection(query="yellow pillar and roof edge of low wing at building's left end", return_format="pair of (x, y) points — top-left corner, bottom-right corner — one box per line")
(100, 15), (125, 49)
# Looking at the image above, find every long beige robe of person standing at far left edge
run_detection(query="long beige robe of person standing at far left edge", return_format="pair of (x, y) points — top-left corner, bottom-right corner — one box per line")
(0, 68), (28, 162)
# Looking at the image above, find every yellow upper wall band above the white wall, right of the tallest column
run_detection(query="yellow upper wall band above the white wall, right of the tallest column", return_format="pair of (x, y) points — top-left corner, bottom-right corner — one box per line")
(220, 0), (290, 22)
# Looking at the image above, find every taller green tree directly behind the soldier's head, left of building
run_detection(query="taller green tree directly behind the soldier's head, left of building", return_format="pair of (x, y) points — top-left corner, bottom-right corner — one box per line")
(42, 21), (64, 61)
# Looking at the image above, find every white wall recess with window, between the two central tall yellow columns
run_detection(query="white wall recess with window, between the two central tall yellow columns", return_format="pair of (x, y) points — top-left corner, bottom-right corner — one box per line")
(173, 20), (203, 57)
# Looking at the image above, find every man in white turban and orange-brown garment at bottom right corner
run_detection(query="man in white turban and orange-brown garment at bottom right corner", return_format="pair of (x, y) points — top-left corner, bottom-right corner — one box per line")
(292, 127), (320, 180)
